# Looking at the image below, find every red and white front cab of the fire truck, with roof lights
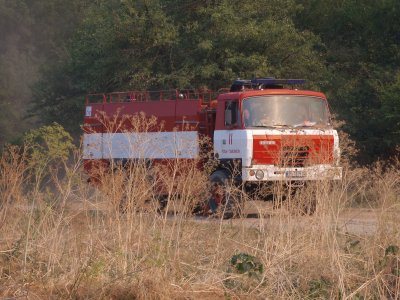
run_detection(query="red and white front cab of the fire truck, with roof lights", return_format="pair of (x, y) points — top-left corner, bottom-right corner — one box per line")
(214, 78), (342, 183)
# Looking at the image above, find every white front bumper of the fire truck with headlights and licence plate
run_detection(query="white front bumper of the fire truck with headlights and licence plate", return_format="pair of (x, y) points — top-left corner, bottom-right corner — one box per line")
(242, 165), (342, 182)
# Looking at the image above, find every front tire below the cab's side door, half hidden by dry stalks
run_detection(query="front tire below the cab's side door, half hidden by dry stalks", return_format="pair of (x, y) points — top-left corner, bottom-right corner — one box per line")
(208, 170), (243, 219)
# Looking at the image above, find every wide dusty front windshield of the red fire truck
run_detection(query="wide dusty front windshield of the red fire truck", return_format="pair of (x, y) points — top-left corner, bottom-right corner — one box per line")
(242, 95), (330, 128)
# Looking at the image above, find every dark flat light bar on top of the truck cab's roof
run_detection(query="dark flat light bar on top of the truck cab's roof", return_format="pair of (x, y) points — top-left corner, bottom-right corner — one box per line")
(230, 77), (306, 92)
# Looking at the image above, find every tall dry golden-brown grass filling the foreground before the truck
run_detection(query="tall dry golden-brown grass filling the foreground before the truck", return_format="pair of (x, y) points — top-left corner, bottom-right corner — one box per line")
(0, 141), (400, 299)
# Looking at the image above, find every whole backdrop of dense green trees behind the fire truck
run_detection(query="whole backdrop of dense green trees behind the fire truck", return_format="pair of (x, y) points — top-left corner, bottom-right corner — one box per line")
(0, 0), (400, 162)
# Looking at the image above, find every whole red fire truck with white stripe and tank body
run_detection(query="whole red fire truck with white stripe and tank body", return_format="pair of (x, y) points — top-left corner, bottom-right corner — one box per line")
(83, 78), (342, 214)
